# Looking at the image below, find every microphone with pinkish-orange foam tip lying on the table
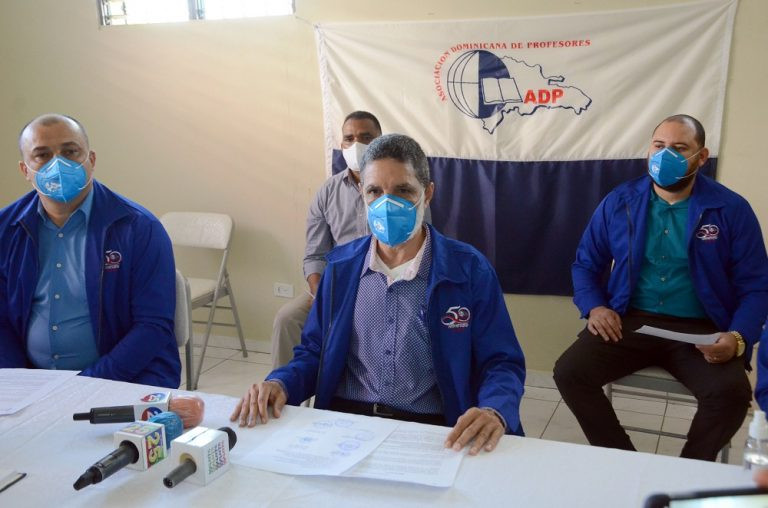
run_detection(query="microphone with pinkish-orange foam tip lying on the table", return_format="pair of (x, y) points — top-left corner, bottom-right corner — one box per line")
(72, 392), (205, 429)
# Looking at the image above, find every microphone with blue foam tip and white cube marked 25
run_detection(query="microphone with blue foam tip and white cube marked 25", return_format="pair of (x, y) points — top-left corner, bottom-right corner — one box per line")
(73, 412), (182, 490)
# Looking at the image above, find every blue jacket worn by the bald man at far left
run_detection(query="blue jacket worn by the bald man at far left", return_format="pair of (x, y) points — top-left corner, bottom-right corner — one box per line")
(0, 181), (181, 388)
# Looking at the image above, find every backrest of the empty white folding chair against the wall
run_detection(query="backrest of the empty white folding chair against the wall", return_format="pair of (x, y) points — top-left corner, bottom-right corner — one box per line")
(160, 212), (234, 249)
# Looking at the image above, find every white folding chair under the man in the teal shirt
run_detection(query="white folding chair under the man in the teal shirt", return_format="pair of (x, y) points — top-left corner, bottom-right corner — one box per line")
(605, 367), (731, 464)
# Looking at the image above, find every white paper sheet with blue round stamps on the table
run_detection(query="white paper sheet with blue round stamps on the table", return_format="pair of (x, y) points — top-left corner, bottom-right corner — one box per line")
(237, 411), (399, 476)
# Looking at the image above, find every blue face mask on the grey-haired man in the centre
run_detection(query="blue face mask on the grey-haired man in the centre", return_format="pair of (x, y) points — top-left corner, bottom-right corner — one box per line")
(368, 194), (424, 247)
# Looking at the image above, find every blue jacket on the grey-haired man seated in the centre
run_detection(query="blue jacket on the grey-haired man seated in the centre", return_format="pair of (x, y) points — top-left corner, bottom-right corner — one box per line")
(267, 226), (525, 435)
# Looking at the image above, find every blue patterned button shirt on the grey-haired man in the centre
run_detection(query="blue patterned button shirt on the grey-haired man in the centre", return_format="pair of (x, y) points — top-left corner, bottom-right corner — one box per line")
(336, 230), (443, 414)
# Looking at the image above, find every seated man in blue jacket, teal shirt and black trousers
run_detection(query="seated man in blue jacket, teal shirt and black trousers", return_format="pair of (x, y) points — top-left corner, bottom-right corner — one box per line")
(554, 115), (768, 460)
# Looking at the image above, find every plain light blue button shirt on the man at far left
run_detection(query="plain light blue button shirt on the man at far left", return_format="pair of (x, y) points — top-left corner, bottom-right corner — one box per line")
(27, 190), (99, 370)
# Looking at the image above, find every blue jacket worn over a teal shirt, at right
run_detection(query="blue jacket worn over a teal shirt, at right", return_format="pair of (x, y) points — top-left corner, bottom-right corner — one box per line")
(572, 174), (768, 363)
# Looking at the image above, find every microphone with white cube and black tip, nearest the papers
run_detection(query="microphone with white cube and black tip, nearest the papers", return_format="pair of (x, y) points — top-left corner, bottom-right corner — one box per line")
(163, 427), (237, 489)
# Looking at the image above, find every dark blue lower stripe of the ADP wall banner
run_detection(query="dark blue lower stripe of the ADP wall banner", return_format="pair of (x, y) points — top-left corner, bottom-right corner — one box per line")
(333, 150), (717, 296)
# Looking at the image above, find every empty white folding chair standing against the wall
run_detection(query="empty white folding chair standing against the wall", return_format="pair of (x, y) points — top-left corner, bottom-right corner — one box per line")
(160, 212), (248, 390)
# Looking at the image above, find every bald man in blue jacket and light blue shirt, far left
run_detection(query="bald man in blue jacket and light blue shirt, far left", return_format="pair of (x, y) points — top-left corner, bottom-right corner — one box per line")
(0, 114), (181, 388)
